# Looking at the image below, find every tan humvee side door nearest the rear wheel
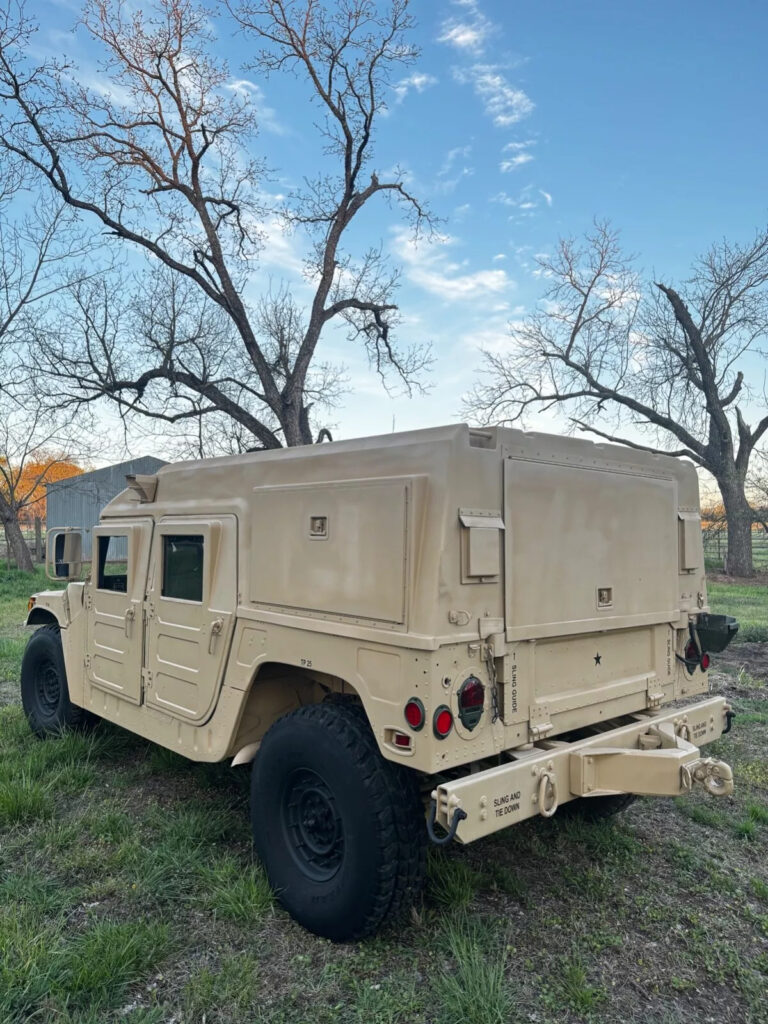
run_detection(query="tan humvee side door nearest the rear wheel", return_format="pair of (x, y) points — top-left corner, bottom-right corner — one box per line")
(144, 515), (238, 723)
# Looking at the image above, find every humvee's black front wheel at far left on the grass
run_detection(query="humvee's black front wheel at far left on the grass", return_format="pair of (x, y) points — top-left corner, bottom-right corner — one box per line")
(22, 626), (98, 738)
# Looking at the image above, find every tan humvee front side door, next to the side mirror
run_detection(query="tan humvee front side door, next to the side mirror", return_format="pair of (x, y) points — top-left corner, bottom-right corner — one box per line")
(85, 518), (153, 703)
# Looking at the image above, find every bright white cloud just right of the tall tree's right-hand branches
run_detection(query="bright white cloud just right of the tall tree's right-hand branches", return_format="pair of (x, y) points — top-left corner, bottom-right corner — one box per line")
(393, 229), (515, 302)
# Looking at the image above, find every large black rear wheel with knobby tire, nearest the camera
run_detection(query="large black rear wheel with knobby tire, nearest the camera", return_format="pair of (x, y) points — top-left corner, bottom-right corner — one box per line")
(256, 701), (426, 942)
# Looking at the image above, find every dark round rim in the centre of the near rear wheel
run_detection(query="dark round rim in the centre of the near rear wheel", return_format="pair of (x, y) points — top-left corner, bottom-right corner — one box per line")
(282, 768), (344, 882)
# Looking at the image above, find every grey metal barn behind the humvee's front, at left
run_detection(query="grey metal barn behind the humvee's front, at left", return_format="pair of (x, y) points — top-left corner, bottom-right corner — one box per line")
(46, 455), (166, 559)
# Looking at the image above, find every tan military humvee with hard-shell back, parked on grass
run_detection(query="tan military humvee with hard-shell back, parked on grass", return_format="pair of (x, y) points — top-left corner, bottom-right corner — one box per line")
(22, 425), (738, 940)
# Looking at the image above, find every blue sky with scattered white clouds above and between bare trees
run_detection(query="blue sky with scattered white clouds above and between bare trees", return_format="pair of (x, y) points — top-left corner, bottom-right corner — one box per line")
(27, 0), (768, 452)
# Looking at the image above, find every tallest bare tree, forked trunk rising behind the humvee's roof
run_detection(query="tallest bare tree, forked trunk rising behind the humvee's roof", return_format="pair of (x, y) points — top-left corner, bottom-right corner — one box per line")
(0, 0), (429, 447)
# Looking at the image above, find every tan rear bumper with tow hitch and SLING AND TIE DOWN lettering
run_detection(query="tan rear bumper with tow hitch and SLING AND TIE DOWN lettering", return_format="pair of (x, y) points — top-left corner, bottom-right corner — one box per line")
(432, 697), (733, 843)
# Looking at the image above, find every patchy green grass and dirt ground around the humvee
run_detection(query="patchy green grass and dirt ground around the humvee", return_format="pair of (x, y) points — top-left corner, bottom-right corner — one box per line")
(0, 574), (768, 1024)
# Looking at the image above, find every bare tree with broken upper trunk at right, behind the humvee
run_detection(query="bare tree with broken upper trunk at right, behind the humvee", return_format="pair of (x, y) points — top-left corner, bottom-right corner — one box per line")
(466, 224), (768, 575)
